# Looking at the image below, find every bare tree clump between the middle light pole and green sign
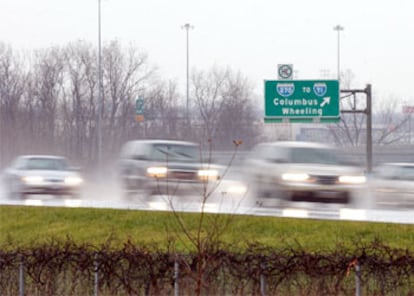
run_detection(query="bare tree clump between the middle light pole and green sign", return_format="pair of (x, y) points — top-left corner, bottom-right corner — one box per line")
(192, 67), (260, 149)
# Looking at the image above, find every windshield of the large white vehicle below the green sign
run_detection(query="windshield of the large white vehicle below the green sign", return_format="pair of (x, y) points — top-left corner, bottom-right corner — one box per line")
(290, 147), (343, 164)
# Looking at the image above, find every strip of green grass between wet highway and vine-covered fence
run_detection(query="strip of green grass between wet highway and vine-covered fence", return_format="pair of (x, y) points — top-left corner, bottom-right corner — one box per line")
(0, 206), (414, 251)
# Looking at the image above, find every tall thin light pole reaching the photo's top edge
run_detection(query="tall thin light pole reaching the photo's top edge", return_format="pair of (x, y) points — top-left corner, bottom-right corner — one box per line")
(97, 0), (102, 170)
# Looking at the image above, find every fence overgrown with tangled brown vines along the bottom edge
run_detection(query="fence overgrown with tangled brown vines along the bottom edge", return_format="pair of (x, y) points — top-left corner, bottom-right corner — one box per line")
(0, 242), (414, 296)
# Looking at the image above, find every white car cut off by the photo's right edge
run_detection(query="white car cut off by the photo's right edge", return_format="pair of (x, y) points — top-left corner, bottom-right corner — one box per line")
(370, 162), (414, 207)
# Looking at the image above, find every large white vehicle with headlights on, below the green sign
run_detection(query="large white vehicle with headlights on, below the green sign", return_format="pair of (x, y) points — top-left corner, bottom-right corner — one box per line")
(244, 141), (366, 205)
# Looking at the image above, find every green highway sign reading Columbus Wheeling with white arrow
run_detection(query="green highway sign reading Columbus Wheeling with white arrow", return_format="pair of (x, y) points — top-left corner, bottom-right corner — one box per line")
(264, 80), (340, 122)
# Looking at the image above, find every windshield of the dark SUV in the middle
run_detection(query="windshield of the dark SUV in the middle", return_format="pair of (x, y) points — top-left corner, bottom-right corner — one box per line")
(151, 144), (199, 162)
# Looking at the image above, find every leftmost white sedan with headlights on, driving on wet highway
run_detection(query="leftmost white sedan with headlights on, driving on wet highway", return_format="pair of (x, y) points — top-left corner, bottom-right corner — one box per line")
(3, 155), (83, 199)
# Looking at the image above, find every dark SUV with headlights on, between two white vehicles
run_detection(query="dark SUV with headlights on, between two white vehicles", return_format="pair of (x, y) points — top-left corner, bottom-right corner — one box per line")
(119, 140), (220, 196)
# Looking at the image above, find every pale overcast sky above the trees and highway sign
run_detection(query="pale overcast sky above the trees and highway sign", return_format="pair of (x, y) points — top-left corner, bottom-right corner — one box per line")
(0, 0), (414, 105)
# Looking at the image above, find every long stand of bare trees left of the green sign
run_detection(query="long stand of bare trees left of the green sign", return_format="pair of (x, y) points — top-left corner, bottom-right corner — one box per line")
(0, 41), (257, 175)
